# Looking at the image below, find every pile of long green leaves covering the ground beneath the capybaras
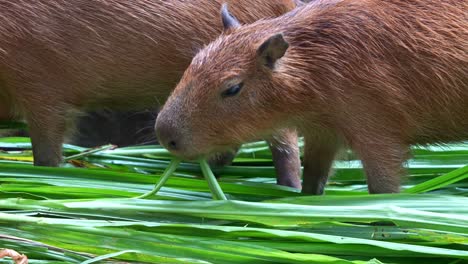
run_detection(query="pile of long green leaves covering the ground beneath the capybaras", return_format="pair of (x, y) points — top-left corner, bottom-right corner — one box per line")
(0, 135), (468, 264)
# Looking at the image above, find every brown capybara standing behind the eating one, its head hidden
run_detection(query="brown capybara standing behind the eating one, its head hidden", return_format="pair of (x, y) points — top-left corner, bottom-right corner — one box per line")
(0, 0), (300, 189)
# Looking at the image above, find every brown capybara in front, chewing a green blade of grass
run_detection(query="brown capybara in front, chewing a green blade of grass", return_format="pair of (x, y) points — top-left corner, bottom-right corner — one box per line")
(156, 0), (468, 194)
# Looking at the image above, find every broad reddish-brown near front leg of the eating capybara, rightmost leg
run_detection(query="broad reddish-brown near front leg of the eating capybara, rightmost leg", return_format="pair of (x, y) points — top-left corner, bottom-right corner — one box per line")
(354, 139), (408, 193)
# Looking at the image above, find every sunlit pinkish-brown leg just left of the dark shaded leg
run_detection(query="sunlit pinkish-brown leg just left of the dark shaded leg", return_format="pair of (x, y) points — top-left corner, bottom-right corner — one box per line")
(268, 129), (301, 189)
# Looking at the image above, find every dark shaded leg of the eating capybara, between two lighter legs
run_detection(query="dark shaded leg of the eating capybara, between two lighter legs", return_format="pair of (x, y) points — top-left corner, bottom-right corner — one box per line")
(302, 137), (338, 195)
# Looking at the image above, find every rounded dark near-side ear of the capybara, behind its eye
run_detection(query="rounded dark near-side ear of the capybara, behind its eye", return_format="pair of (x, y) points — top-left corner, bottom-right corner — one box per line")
(257, 33), (289, 69)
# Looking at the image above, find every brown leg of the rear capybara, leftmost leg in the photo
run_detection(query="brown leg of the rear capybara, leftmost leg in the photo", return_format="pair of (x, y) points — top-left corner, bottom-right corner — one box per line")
(26, 109), (66, 167)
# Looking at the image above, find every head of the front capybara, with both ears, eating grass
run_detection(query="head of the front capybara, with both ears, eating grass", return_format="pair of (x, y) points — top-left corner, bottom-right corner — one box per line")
(156, 5), (289, 159)
